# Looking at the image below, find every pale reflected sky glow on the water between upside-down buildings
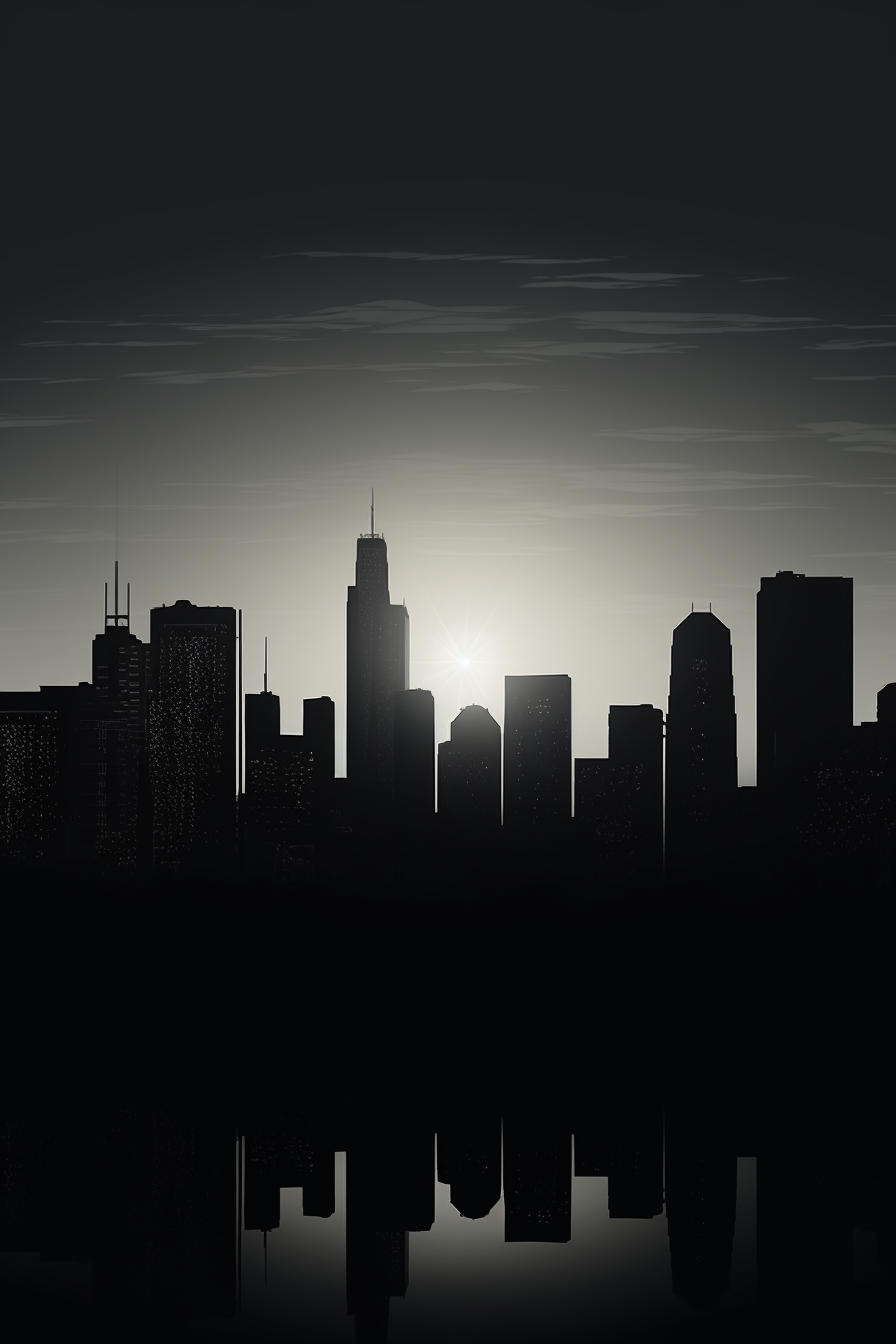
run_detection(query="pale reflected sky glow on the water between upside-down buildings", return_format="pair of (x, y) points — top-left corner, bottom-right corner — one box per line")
(229, 1153), (756, 1344)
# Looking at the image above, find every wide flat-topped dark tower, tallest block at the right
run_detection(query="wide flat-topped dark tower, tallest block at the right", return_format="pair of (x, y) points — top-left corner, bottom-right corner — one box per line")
(756, 570), (853, 789)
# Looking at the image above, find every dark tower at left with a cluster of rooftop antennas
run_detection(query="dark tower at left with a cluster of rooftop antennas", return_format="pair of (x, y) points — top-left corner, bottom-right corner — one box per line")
(91, 560), (152, 868)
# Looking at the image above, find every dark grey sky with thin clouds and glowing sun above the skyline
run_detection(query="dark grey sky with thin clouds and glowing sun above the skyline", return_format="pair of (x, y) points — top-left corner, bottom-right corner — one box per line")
(0, 3), (896, 784)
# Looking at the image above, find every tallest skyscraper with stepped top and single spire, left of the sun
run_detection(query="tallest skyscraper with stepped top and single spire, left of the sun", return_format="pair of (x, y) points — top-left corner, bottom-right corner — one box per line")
(345, 505), (410, 827)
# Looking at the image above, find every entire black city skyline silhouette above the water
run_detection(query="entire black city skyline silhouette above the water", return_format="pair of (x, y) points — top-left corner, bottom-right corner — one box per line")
(0, 509), (896, 894)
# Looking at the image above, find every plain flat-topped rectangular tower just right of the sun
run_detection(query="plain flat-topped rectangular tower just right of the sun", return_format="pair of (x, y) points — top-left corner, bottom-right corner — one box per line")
(504, 676), (572, 831)
